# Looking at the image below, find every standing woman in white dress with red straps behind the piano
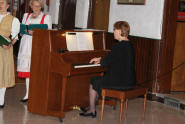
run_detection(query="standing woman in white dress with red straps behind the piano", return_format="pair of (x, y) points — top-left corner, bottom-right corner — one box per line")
(17, 0), (52, 102)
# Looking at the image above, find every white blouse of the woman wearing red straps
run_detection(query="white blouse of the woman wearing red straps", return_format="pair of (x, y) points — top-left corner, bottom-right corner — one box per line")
(22, 12), (52, 29)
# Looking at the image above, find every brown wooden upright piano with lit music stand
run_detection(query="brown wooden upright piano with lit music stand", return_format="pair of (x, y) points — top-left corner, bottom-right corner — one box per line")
(28, 29), (109, 119)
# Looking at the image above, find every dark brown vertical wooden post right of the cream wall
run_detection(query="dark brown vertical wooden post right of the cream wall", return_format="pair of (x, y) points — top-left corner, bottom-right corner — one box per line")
(154, 0), (178, 93)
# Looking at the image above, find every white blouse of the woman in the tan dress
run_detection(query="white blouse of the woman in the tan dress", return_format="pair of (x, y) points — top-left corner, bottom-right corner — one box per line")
(0, 12), (20, 39)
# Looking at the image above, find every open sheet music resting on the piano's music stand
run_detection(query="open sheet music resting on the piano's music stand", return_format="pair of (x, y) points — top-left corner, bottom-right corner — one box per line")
(66, 32), (94, 51)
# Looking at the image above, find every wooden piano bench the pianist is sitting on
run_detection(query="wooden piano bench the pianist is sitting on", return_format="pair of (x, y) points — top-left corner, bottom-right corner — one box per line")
(101, 87), (148, 124)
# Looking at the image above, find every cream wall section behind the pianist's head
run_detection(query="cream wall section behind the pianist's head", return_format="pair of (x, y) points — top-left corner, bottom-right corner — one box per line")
(109, 0), (164, 39)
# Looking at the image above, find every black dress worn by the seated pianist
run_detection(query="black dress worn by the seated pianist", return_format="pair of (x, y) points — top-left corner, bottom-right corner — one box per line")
(91, 41), (136, 96)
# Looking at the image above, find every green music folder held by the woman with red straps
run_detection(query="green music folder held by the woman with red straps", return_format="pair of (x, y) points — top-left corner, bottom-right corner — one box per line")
(20, 24), (48, 35)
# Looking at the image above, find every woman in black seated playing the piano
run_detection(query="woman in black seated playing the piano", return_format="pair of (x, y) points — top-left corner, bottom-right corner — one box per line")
(80, 21), (136, 118)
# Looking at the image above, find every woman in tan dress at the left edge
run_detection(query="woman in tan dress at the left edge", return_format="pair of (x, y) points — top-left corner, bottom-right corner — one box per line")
(0, 0), (20, 108)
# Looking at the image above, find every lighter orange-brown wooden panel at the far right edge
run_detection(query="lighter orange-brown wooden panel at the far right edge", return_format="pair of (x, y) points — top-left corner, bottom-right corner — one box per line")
(171, 22), (185, 91)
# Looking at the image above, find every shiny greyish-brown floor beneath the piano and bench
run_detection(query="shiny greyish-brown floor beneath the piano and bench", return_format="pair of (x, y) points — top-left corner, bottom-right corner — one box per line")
(0, 84), (185, 124)
